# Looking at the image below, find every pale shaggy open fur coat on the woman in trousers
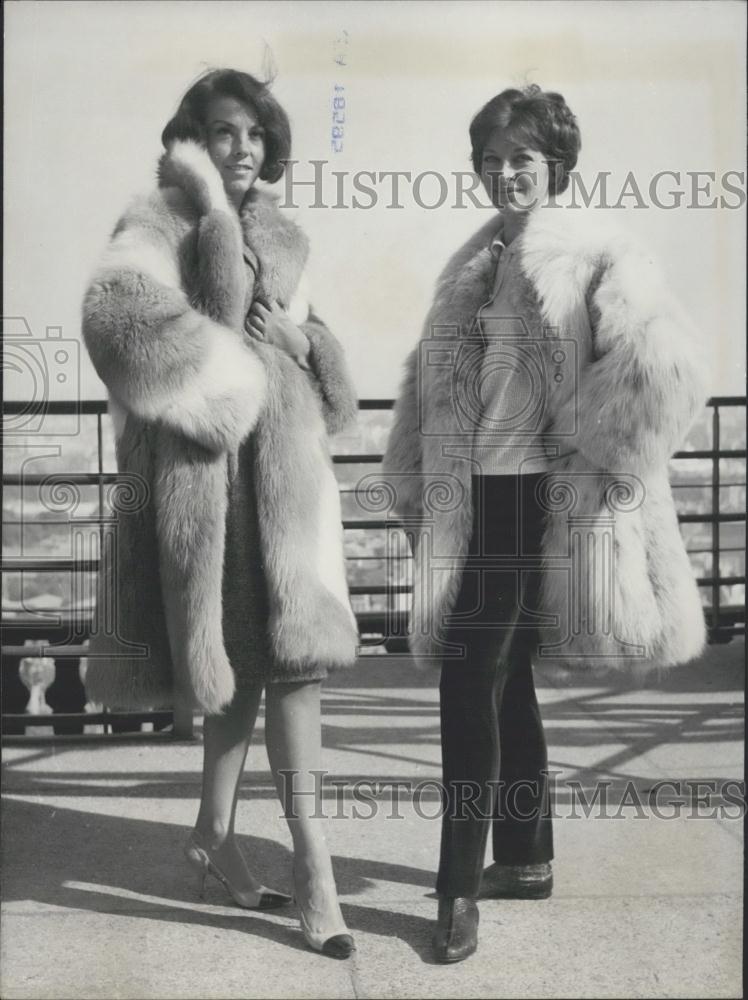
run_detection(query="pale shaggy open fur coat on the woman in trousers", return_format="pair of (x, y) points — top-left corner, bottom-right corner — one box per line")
(384, 209), (706, 668)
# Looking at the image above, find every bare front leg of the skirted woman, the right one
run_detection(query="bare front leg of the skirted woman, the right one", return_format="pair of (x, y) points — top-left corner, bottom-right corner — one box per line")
(265, 681), (345, 934)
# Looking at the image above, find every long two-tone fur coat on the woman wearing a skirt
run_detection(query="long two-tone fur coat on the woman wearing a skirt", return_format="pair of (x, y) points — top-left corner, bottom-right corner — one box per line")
(83, 143), (357, 712)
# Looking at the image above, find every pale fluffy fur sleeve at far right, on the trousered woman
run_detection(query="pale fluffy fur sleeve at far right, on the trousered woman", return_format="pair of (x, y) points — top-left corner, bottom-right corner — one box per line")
(551, 237), (708, 474)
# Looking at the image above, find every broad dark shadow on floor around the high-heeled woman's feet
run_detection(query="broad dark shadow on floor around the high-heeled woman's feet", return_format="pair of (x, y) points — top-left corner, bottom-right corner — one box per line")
(3, 799), (434, 959)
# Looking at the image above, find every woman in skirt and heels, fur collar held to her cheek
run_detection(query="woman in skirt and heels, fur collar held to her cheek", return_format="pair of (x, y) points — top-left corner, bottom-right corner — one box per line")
(83, 70), (357, 957)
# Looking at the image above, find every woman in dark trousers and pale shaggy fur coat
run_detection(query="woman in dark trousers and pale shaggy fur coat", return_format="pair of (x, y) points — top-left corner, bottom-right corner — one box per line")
(384, 86), (706, 962)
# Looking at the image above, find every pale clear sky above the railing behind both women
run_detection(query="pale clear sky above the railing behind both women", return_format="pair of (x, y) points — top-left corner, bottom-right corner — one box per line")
(4, 0), (746, 399)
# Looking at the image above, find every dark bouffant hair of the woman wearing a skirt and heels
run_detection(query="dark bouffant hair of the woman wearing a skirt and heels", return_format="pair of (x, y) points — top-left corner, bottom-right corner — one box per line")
(161, 69), (291, 184)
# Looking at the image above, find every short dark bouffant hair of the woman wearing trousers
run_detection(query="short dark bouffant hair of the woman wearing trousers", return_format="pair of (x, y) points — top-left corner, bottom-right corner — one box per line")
(470, 84), (582, 194)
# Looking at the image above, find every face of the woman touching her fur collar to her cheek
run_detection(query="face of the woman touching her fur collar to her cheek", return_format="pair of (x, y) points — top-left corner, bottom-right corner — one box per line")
(205, 97), (265, 207)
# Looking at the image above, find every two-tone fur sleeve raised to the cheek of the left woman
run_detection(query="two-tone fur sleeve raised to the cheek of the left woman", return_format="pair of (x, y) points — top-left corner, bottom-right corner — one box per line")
(83, 141), (266, 452)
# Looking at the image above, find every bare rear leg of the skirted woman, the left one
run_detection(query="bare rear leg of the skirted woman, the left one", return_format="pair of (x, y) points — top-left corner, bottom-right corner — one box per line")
(195, 683), (262, 892)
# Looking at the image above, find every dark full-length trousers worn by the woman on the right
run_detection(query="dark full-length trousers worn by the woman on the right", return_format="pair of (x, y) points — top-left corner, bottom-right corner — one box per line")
(436, 475), (553, 897)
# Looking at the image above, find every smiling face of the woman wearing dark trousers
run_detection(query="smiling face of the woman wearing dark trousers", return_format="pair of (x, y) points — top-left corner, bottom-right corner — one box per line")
(481, 128), (550, 212)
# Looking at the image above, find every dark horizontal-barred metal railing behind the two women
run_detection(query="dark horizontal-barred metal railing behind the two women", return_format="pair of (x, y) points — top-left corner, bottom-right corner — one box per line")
(2, 396), (746, 737)
